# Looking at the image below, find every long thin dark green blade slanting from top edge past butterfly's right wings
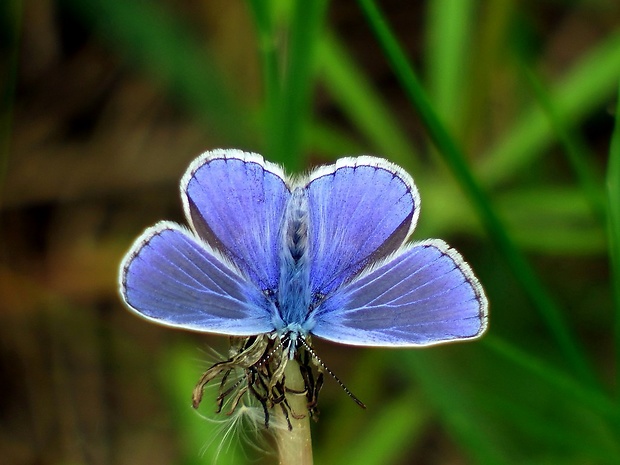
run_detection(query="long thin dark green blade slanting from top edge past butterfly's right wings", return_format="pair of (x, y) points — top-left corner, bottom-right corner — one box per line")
(359, 0), (598, 385)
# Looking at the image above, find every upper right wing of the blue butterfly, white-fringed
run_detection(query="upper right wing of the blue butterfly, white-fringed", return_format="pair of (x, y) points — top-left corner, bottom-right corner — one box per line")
(306, 157), (420, 295)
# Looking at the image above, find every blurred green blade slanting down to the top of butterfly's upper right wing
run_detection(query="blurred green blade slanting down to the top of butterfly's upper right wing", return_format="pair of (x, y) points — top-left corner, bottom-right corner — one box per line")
(318, 33), (417, 172)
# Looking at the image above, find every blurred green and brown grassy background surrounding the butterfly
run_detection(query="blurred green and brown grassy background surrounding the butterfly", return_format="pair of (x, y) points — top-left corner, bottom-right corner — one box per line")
(0, 0), (620, 465)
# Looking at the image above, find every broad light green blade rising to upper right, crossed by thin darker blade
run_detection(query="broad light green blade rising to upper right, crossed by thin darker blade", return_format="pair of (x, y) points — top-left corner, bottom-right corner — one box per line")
(477, 32), (620, 185)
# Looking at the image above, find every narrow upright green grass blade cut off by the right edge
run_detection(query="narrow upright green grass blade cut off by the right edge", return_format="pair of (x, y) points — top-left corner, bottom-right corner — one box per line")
(607, 81), (620, 392)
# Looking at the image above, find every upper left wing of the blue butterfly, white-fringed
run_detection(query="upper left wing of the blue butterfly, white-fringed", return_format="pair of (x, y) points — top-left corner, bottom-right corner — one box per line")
(181, 150), (290, 290)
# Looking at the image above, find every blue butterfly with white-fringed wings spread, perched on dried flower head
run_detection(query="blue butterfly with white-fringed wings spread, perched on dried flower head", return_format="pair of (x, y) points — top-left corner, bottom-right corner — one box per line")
(120, 150), (488, 357)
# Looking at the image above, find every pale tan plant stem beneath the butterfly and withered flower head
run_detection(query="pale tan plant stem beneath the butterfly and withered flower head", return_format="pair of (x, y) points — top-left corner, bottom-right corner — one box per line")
(275, 360), (312, 465)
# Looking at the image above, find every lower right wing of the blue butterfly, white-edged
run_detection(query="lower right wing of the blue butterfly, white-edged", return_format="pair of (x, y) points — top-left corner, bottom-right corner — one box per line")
(311, 240), (488, 346)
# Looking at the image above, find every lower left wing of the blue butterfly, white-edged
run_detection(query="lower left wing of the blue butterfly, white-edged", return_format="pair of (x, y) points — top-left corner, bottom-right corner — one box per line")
(120, 222), (274, 336)
